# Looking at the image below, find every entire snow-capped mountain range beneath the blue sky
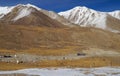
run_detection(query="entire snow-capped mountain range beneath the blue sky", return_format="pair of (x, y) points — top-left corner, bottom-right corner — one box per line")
(0, 4), (120, 32)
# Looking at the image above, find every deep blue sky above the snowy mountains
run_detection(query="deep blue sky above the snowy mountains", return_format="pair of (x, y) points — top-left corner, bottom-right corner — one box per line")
(0, 0), (120, 12)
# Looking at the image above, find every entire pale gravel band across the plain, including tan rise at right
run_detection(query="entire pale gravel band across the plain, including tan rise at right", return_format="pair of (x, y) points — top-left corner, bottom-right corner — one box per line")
(0, 49), (120, 63)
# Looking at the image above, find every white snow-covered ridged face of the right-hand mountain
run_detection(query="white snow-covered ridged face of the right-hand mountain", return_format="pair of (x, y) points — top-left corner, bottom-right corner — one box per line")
(59, 6), (106, 29)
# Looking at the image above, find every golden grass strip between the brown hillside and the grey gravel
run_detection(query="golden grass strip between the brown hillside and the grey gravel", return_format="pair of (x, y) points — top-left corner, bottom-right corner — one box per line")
(0, 46), (86, 56)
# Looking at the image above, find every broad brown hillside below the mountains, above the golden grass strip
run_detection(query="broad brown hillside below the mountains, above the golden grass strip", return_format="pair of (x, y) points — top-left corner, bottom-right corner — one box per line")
(0, 25), (120, 51)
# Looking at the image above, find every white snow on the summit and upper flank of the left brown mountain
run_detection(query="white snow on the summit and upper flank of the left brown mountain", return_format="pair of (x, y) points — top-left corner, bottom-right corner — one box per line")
(0, 4), (41, 20)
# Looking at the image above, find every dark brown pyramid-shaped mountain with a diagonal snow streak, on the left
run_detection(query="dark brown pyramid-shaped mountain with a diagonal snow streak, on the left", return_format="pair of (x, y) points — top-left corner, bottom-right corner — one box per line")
(0, 4), (66, 27)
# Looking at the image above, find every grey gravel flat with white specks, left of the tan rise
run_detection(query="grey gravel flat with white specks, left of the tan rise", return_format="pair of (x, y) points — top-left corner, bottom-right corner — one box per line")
(0, 54), (87, 62)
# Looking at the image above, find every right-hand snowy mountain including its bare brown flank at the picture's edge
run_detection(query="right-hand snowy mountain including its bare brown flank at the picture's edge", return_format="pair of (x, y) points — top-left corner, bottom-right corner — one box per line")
(58, 6), (120, 31)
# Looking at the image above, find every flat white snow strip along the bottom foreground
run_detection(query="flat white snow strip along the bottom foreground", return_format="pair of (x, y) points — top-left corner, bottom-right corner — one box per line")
(0, 67), (120, 76)
